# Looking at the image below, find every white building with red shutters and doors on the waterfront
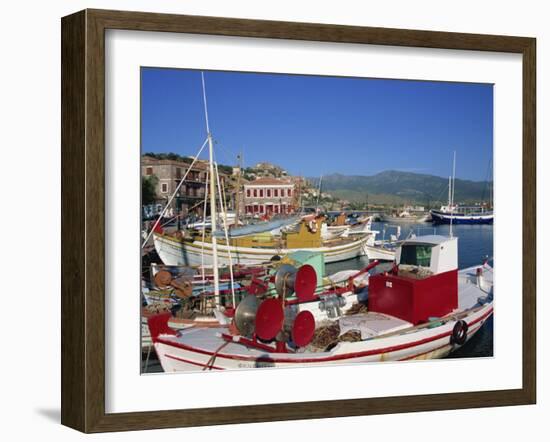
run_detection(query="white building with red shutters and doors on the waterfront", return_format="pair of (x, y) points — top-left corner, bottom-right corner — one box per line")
(244, 177), (295, 215)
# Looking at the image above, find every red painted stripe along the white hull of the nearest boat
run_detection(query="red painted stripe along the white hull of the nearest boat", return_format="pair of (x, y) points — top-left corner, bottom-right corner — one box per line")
(157, 308), (493, 364)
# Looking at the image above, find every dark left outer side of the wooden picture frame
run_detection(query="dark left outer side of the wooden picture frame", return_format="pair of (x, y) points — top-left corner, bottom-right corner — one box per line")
(61, 11), (87, 431)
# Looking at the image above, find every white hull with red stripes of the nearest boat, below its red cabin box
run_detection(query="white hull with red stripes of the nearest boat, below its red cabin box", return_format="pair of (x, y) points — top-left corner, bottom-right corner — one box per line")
(154, 267), (493, 372)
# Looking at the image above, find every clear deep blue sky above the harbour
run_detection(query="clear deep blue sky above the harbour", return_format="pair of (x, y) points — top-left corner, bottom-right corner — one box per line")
(141, 68), (493, 180)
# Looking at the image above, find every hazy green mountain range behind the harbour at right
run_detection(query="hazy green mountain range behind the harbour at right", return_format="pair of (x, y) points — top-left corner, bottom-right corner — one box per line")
(308, 170), (493, 205)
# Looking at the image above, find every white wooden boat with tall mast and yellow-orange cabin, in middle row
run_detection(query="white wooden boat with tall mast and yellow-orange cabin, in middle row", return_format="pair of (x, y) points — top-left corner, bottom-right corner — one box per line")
(147, 75), (384, 269)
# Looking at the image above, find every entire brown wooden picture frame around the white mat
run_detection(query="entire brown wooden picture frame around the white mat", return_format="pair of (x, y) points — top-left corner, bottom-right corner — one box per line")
(61, 10), (537, 432)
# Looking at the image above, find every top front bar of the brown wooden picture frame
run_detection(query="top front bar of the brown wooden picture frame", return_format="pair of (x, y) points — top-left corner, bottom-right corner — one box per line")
(89, 9), (529, 53)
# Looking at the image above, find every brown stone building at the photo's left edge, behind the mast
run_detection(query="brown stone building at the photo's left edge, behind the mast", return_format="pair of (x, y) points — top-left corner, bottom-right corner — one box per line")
(141, 156), (230, 214)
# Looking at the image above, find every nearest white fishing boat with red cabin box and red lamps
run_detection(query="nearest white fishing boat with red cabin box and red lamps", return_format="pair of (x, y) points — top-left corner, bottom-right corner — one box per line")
(149, 235), (493, 372)
